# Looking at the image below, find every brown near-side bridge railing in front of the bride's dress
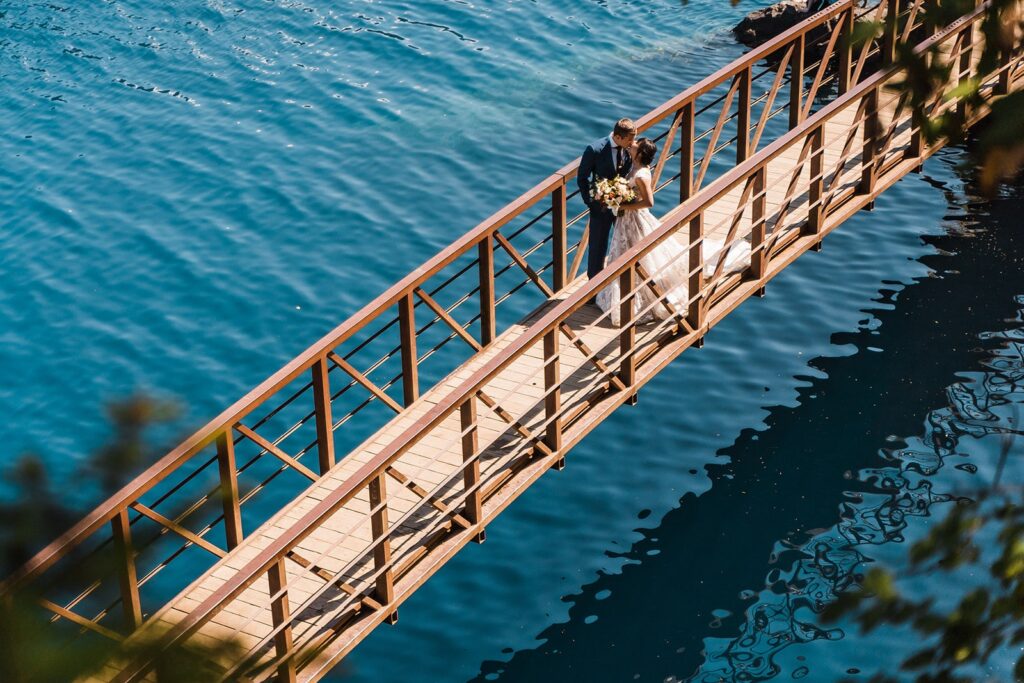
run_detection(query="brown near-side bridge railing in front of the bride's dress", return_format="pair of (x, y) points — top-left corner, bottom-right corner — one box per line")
(92, 2), (1021, 681)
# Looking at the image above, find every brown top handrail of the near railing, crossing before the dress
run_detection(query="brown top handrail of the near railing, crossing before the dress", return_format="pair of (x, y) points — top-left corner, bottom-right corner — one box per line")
(105, 2), (988, 682)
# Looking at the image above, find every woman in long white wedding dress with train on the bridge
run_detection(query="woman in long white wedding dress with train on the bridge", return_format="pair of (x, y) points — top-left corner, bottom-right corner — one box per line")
(597, 137), (751, 326)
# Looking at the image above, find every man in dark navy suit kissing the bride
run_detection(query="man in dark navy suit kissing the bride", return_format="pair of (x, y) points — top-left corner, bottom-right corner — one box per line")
(577, 119), (637, 279)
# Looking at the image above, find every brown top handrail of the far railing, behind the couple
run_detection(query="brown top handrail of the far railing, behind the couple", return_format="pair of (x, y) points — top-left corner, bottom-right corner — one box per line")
(0, 0), (857, 595)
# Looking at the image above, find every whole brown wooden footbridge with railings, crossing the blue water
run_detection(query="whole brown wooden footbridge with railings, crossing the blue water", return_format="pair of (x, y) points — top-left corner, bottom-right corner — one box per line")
(3, 0), (1022, 681)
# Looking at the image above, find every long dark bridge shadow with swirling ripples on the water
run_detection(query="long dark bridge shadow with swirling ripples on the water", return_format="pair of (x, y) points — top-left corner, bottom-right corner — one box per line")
(473, 174), (1024, 681)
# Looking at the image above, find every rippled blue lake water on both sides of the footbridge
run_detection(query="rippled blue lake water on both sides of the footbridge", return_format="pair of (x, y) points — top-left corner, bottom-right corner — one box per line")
(0, 0), (1024, 682)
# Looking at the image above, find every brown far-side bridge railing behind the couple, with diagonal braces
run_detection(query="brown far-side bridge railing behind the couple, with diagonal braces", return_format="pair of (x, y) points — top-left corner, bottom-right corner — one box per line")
(2, 0), (920, 663)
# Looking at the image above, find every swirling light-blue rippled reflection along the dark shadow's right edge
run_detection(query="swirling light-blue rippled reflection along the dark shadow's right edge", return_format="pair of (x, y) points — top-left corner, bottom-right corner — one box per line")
(690, 321), (1024, 683)
